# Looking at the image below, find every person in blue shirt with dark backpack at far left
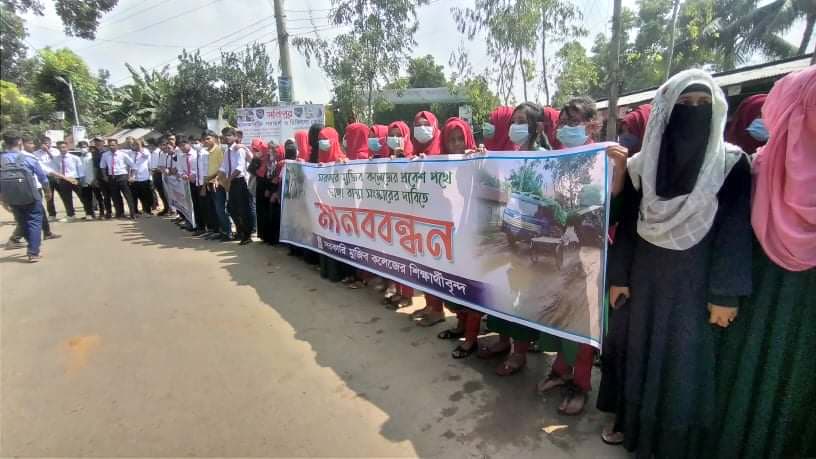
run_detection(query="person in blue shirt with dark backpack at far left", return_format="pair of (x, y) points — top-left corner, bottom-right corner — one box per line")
(0, 133), (51, 263)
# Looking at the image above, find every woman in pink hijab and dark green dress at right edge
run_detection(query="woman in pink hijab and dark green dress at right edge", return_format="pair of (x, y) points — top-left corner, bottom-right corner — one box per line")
(698, 66), (816, 458)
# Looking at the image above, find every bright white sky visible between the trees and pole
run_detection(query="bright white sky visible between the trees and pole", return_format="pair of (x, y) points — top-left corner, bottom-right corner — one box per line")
(23, 0), (802, 103)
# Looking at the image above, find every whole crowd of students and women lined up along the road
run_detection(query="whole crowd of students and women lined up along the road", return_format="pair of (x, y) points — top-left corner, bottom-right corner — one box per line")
(0, 67), (816, 458)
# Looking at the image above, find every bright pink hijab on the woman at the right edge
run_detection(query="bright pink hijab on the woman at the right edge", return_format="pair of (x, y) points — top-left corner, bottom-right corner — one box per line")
(751, 66), (816, 271)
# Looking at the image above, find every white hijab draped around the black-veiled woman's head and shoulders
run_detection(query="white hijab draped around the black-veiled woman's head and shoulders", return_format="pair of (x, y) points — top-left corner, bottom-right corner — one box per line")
(627, 70), (743, 250)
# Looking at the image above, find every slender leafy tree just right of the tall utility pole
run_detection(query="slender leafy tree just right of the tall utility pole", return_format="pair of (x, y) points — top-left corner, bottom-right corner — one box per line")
(292, 0), (428, 121)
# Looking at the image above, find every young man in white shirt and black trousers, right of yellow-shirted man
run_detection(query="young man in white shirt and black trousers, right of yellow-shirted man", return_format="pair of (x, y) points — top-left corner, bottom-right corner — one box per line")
(218, 127), (252, 245)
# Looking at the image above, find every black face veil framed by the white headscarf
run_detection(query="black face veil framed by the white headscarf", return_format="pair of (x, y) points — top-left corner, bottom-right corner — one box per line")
(655, 84), (712, 199)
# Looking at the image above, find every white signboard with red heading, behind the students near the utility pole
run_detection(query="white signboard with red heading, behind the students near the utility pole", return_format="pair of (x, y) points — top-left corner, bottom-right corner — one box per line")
(236, 104), (325, 144)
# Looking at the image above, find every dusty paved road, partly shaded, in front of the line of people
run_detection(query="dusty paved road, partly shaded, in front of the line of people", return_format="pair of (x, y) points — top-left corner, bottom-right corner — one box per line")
(0, 211), (625, 458)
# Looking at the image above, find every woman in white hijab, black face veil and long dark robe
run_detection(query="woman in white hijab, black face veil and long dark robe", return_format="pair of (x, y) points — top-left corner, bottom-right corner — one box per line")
(604, 70), (751, 457)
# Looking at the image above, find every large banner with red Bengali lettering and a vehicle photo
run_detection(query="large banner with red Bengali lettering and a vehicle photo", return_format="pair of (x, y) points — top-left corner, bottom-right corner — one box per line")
(281, 144), (611, 347)
